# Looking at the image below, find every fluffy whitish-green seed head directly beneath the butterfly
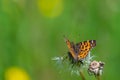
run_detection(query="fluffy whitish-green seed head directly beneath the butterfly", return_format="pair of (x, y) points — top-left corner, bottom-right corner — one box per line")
(52, 52), (94, 75)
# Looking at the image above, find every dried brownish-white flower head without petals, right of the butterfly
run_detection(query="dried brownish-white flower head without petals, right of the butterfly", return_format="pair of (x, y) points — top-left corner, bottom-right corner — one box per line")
(88, 61), (105, 76)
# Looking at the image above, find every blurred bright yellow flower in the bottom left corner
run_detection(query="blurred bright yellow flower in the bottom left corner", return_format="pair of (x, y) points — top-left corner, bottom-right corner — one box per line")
(5, 67), (30, 80)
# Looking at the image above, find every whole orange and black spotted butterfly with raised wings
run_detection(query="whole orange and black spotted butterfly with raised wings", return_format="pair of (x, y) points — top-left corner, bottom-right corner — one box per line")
(65, 38), (96, 64)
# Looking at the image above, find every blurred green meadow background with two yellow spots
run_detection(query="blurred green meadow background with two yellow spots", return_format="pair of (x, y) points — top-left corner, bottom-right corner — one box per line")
(0, 0), (120, 80)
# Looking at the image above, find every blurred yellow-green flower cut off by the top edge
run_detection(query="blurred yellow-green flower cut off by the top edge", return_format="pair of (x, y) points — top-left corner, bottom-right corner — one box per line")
(37, 0), (63, 18)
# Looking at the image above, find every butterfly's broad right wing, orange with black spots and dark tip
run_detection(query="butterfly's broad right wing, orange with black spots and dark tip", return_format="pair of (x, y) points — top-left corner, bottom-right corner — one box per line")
(77, 40), (96, 60)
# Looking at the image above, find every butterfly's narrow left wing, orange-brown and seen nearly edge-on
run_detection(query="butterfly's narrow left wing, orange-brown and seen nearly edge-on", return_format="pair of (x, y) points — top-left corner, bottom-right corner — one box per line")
(65, 39), (77, 60)
